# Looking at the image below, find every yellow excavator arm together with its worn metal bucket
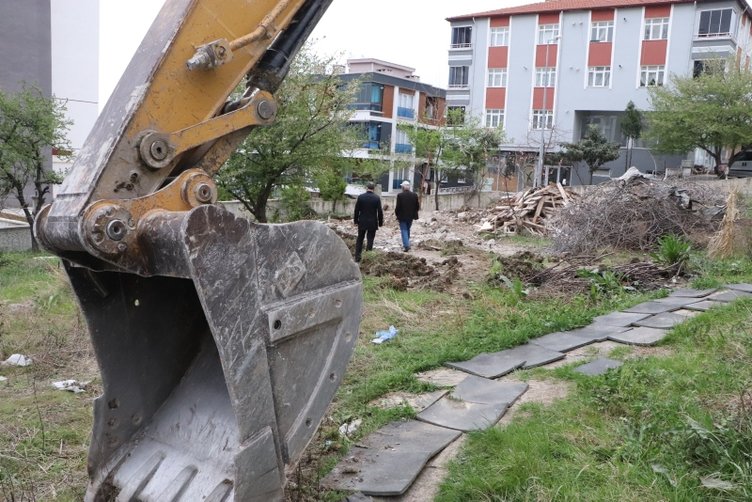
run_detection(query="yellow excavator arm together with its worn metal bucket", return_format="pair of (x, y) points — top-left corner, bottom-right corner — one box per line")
(35, 0), (361, 501)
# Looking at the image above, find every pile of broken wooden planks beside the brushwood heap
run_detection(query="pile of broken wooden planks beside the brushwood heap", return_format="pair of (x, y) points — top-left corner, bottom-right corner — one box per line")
(476, 183), (579, 235)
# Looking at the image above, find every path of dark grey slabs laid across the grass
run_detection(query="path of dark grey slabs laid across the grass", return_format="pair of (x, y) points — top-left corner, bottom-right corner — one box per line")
(322, 284), (752, 502)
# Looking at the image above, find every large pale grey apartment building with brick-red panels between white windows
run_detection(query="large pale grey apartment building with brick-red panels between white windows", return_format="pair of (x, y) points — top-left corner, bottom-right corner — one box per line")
(447, 0), (752, 184)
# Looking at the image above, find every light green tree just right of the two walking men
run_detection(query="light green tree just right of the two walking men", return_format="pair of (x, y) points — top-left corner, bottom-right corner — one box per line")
(398, 110), (504, 210)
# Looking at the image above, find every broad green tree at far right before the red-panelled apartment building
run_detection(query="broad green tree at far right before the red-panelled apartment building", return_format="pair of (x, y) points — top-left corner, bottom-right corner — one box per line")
(647, 61), (752, 167)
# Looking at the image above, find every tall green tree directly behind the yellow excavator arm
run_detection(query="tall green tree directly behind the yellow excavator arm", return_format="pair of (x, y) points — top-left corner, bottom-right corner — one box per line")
(217, 50), (357, 223)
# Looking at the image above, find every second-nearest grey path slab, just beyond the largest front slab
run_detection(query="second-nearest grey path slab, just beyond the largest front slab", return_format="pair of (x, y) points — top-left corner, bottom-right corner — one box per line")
(417, 396), (509, 432)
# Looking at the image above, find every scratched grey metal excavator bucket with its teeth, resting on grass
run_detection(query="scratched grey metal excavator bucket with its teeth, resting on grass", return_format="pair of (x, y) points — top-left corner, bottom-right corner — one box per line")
(68, 206), (361, 502)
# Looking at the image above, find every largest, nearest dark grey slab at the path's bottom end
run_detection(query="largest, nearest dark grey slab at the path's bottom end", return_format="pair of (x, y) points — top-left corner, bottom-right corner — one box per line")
(321, 420), (461, 497)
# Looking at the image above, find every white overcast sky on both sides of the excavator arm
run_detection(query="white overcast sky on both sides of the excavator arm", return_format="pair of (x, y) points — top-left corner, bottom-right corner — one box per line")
(99, 0), (524, 109)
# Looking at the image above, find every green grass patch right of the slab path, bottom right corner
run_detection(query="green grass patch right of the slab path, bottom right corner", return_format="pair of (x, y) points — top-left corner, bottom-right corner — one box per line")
(438, 301), (752, 501)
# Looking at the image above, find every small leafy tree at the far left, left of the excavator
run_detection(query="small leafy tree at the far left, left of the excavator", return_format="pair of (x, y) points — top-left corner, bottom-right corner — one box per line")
(0, 88), (70, 251)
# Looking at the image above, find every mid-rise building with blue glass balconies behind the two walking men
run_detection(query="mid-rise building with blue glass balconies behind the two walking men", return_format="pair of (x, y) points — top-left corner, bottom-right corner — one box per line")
(341, 58), (446, 191)
